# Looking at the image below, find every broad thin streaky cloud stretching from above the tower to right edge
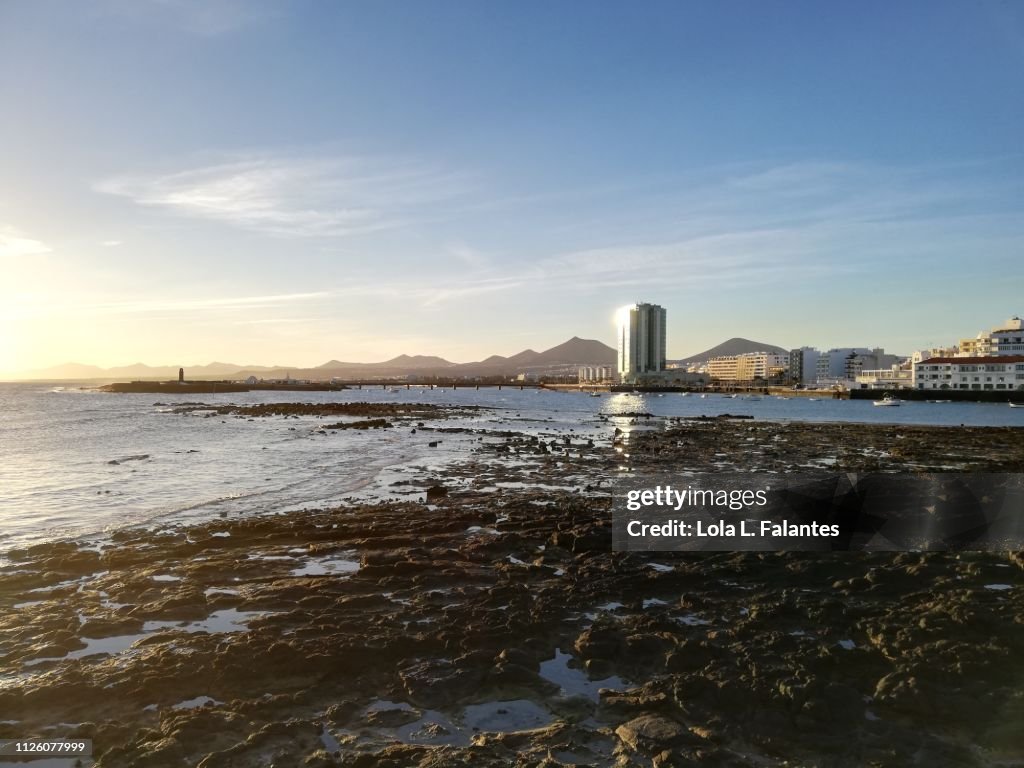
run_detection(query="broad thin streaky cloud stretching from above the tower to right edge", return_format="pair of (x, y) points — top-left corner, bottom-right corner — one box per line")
(527, 157), (1024, 291)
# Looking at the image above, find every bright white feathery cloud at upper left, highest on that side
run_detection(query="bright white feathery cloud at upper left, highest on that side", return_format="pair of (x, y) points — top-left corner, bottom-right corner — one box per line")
(96, 156), (470, 237)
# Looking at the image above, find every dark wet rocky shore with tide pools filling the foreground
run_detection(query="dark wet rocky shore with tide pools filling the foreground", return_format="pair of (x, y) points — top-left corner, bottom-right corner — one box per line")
(0, 409), (1024, 768)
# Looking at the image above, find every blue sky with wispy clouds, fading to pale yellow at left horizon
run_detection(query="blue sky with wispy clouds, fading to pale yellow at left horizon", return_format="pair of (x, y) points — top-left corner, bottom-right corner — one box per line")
(0, 0), (1024, 378)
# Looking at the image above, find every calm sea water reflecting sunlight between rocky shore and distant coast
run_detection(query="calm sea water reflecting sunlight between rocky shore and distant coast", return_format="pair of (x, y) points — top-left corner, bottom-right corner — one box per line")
(0, 382), (1024, 552)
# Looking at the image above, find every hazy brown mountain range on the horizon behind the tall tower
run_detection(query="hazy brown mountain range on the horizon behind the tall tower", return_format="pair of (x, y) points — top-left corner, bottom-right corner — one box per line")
(19, 336), (786, 381)
